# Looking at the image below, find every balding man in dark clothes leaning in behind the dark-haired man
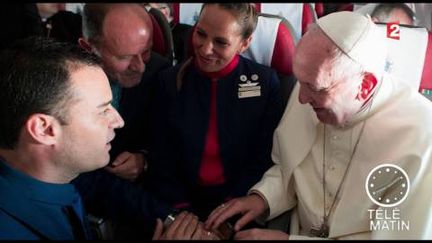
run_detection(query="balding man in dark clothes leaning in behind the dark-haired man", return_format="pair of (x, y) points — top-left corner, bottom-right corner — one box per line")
(79, 3), (171, 181)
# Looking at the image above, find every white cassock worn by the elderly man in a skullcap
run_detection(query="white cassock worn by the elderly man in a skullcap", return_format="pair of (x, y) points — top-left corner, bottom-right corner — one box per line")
(251, 73), (432, 239)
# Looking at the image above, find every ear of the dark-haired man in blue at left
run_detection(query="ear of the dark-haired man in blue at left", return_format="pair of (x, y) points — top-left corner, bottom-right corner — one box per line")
(25, 113), (60, 145)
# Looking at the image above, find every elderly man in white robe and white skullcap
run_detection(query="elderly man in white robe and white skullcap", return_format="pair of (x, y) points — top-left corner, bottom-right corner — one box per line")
(206, 12), (432, 240)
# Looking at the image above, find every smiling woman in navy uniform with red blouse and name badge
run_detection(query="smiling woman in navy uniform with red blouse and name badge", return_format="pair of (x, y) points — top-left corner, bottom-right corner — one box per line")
(148, 3), (284, 224)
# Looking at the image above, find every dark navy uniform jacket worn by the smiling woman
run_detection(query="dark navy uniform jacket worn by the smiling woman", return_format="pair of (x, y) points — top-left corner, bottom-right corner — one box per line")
(148, 57), (284, 219)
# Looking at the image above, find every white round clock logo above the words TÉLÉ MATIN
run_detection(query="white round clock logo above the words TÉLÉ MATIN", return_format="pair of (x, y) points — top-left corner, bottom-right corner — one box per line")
(365, 164), (410, 207)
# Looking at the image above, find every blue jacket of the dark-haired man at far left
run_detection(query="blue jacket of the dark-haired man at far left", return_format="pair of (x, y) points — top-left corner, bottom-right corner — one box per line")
(0, 161), (92, 240)
